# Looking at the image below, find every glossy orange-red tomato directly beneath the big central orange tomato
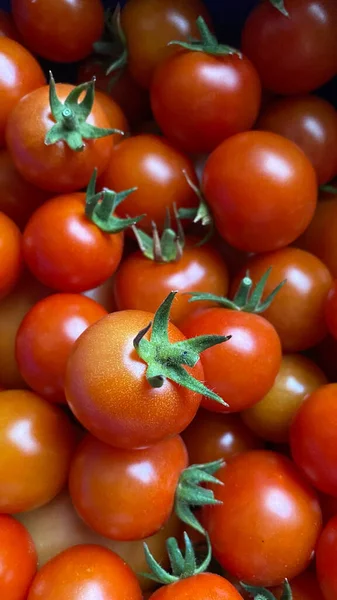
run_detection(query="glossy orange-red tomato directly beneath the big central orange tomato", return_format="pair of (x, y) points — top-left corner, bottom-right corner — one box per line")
(69, 435), (188, 541)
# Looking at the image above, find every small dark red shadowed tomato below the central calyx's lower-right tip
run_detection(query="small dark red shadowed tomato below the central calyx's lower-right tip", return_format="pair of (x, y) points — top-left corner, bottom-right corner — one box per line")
(182, 408), (263, 465)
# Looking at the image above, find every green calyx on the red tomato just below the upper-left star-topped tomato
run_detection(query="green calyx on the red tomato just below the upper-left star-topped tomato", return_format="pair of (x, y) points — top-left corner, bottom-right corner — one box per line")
(85, 169), (144, 233)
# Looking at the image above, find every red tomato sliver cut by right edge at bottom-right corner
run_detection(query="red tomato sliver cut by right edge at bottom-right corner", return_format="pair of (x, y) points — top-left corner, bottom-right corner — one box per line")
(316, 516), (337, 600)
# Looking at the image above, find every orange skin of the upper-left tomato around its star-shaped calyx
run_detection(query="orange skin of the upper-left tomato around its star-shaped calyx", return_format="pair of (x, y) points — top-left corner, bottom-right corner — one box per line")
(6, 83), (113, 193)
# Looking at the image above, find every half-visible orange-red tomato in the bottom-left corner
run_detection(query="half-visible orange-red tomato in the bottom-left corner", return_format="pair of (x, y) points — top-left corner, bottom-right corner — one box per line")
(0, 515), (37, 600)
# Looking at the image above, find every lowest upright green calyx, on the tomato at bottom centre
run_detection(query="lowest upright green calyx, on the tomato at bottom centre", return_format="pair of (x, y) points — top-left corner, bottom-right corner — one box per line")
(140, 532), (212, 585)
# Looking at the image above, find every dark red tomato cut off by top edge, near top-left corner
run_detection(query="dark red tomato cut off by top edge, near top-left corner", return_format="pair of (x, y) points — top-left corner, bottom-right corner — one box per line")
(11, 0), (104, 62)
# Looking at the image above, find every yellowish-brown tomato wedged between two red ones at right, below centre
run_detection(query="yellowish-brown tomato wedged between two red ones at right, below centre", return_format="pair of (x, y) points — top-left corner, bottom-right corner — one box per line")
(242, 354), (327, 443)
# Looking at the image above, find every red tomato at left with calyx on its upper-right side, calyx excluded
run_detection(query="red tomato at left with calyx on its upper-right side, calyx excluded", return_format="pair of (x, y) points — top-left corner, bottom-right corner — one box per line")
(23, 193), (124, 293)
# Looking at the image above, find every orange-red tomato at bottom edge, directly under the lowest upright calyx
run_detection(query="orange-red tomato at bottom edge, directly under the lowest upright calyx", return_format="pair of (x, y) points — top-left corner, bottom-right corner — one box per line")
(150, 573), (242, 600)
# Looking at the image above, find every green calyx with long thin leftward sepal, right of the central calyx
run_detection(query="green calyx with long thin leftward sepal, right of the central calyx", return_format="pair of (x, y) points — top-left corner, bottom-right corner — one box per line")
(189, 267), (286, 314)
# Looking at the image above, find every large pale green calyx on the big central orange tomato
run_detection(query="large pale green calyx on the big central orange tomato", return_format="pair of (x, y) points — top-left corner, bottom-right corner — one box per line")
(133, 292), (231, 406)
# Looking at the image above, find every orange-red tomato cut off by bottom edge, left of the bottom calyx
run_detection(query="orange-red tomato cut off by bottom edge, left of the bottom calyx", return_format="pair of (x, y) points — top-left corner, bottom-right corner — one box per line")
(27, 544), (142, 600)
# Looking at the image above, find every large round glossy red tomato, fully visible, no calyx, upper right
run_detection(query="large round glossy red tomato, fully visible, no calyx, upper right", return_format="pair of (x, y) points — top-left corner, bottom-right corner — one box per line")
(203, 131), (317, 253)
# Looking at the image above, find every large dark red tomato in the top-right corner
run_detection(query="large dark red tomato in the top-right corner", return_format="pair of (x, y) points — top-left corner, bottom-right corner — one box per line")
(242, 0), (337, 94)
